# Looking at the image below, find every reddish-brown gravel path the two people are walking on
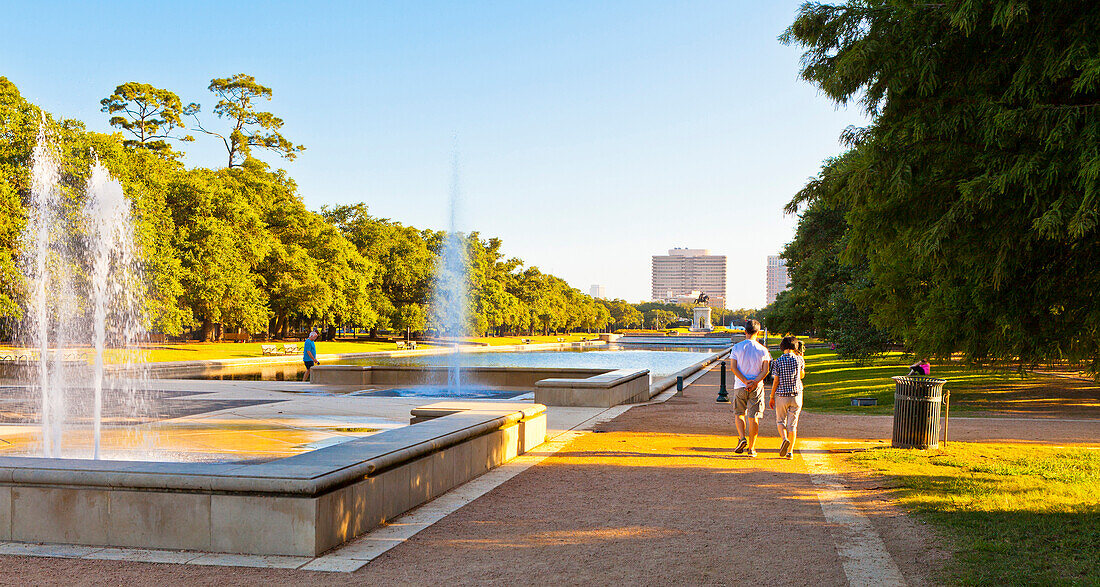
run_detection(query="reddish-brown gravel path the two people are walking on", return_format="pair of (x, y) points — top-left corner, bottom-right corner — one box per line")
(0, 364), (1100, 586)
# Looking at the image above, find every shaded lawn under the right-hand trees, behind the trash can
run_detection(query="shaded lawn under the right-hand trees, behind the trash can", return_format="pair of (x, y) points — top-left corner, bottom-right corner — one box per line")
(800, 348), (1100, 417)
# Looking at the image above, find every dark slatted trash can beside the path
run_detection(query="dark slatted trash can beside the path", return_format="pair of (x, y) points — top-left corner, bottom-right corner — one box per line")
(891, 376), (947, 448)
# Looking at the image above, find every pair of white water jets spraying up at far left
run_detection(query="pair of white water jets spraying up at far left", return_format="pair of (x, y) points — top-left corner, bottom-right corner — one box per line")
(21, 123), (144, 458)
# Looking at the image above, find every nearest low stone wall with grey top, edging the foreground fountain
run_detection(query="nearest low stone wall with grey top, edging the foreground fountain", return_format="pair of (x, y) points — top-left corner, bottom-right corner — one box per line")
(0, 402), (546, 556)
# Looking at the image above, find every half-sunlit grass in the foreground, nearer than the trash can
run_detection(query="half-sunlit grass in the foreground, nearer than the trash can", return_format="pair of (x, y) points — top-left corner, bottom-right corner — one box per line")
(848, 442), (1100, 585)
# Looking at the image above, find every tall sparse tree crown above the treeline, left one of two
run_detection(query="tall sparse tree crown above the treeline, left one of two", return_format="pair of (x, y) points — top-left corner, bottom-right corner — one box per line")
(99, 81), (199, 154)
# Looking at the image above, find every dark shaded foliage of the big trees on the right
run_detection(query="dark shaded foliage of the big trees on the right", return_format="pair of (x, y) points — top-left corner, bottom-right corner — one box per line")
(782, 0), (1100, 372)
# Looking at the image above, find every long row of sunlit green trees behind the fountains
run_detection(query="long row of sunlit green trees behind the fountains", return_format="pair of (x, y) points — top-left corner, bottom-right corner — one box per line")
(0, 75), (620, 341)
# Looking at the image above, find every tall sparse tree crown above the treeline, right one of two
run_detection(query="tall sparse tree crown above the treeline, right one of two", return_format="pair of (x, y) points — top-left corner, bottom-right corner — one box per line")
(193, 74), (306, 167)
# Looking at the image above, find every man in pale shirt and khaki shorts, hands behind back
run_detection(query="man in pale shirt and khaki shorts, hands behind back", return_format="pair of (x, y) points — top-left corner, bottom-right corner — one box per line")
(729, 320), (771, 456)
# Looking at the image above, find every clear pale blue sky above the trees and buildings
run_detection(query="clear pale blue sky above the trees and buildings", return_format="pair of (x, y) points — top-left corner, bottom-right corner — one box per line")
(0, 0), (865, 307)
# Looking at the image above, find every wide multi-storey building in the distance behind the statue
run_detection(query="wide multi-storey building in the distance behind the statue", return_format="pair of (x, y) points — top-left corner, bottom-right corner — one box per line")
(651, 248), (726, 308)
